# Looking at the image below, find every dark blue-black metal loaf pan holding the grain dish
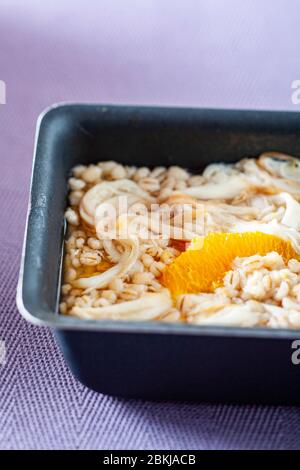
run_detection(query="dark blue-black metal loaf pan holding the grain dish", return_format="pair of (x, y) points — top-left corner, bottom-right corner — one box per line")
(17, 104), (300, 404)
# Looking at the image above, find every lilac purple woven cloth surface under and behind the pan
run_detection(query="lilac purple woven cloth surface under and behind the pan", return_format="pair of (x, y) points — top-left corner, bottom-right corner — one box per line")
(0, 0), (300, 449)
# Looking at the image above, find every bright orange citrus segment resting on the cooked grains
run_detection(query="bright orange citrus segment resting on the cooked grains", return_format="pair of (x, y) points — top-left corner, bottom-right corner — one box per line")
(161, 232), (299, 297)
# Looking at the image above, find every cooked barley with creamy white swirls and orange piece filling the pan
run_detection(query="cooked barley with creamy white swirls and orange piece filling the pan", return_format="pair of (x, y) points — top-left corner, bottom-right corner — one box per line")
(60, 153), (300, 328)
